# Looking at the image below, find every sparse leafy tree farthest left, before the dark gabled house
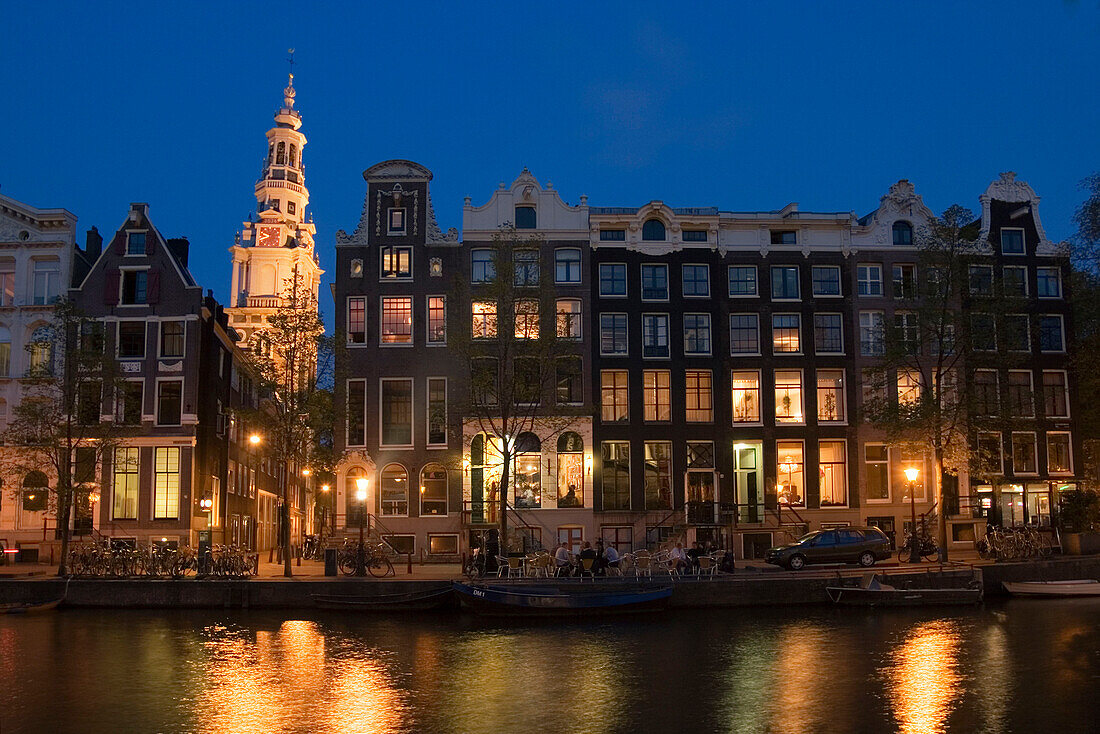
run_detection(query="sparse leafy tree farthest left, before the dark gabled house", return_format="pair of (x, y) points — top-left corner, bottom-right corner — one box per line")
(3, 299), (123, 576)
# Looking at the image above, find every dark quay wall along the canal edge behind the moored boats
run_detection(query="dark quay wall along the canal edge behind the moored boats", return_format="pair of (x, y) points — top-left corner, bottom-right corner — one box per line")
(0, 556), (1100, 613)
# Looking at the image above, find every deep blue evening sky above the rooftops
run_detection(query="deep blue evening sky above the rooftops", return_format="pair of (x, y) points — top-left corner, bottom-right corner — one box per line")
(0, 0), (1100, 323)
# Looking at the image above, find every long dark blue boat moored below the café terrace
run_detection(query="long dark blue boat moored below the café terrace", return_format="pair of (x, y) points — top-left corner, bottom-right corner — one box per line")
(454, 581), (672, 616)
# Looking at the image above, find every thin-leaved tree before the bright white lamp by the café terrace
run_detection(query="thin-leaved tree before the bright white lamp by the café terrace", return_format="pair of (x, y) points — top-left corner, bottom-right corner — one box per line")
(448, 226), (585, 549)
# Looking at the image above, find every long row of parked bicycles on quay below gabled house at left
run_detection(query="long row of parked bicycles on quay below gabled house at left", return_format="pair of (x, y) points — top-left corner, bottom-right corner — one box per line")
(68, 543), (260, 579)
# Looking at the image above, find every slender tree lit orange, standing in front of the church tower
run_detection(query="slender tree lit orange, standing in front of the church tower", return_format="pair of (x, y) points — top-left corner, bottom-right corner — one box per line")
(241, 269), (331, 577)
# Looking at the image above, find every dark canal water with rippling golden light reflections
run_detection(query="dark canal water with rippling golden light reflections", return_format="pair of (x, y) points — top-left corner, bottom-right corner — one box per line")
(0, 600), (1100, 734)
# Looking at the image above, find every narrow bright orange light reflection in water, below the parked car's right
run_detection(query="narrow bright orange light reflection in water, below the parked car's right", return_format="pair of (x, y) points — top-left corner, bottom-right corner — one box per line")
(881, 620), (964, 734)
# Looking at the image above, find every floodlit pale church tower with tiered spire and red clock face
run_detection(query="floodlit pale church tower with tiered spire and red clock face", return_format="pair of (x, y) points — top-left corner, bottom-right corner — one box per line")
(226, 74), (325, 347)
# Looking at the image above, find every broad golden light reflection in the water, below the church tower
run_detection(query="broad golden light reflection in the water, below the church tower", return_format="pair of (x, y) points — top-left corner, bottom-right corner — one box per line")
(195, 621), (405, 734)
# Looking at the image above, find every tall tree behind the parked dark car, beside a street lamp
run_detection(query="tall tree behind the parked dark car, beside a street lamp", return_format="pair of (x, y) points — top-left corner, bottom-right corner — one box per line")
(861, 206), (1012, 561)
